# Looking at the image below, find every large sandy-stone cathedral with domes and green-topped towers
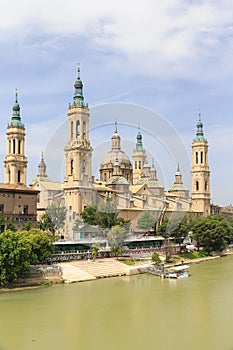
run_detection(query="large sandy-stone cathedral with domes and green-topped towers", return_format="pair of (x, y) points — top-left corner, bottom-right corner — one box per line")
(0, 67), (210, 238)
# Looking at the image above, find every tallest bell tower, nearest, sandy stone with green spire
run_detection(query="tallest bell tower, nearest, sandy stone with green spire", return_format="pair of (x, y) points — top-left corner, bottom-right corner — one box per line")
(63, 66), (92, 213)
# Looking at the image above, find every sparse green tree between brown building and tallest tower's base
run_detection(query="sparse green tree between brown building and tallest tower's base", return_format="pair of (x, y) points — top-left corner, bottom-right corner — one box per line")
(46, 201), (67, 231)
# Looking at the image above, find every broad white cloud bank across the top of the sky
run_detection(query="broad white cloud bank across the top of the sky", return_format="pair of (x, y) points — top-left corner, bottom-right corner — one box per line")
(0, 0), (233, 79)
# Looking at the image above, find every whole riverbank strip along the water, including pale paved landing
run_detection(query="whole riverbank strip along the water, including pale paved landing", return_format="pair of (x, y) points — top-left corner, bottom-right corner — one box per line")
(0, 252), (232, 293)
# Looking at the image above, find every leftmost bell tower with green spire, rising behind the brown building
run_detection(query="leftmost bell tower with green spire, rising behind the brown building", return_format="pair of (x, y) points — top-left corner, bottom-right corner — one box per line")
(4, 91), (27, 186)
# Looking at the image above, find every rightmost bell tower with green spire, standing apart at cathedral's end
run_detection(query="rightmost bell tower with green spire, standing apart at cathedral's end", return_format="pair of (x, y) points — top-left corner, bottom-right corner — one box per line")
(191, 113), (210, 216)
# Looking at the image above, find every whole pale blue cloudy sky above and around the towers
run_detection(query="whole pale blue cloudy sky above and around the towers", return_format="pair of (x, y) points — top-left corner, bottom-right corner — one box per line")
(0, 0), (233, 205)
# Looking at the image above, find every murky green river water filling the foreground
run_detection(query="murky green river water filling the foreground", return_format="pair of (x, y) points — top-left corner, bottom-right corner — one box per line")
(0, 256), (233, 350)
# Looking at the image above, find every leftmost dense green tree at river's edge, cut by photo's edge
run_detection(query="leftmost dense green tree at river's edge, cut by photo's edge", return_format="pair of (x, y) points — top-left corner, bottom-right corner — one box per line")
(0, 231), (31, 285)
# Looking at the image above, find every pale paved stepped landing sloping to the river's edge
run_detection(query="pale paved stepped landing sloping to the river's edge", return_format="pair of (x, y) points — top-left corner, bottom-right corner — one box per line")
(58, 258), (146, 283)
